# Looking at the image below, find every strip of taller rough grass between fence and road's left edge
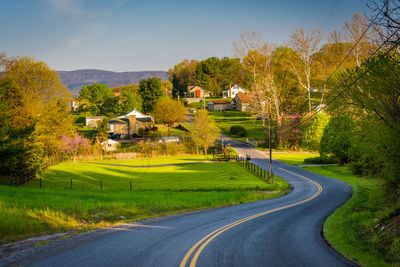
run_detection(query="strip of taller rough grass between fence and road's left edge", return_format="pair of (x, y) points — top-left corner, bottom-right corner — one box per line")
(0, 186), (282, 243)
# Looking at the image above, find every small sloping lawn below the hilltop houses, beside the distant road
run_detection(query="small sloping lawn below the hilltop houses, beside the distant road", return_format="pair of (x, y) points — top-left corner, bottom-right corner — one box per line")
(209, 111), (264, 141)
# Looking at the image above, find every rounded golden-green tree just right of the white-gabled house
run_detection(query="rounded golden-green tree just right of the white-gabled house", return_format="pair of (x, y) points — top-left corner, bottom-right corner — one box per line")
(153, 97), (186, 132)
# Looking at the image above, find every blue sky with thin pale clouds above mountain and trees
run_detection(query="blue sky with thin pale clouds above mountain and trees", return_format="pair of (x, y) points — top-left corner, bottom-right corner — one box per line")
(0, 0), (370, 72)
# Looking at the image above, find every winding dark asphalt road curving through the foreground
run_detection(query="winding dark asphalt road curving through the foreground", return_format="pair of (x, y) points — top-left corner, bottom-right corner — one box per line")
(4, 141), (355, 266)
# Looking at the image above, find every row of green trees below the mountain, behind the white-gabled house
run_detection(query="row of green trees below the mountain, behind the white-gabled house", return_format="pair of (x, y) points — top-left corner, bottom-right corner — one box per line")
(77, 77), (172, 117)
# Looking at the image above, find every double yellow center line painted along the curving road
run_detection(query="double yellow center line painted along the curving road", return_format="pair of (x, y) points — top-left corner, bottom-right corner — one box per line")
(179, 168), (322, 267)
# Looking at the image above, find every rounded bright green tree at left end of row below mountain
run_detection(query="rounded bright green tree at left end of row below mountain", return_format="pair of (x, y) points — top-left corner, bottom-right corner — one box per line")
(78, 83), (114, 115)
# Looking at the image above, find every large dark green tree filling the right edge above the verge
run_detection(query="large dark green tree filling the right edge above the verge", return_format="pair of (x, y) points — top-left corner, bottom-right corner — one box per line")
(336, 52), (400, 188)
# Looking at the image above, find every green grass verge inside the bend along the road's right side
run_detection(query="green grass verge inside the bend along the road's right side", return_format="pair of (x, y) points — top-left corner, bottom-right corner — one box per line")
(303, 166), (400, 266)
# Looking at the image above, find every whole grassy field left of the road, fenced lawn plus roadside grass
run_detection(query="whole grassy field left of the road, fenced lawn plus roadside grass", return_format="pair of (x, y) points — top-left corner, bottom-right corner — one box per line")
(0, 157), (289, 246)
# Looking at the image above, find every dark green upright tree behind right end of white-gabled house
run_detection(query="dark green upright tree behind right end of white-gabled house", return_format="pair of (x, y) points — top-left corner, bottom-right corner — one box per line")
(139, 77), (163, 112)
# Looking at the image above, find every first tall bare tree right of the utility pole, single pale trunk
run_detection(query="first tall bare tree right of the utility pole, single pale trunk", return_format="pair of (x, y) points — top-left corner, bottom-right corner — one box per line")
(288, 28), (322, 112)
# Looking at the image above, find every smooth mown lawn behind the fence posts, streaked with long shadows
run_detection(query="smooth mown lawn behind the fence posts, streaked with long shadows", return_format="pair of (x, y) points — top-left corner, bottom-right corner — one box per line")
(27, 162), (273, 191)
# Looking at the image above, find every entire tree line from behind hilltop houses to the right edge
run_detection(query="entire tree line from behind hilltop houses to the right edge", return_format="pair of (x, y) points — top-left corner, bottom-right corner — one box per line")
(169, 6), (400, 192)
